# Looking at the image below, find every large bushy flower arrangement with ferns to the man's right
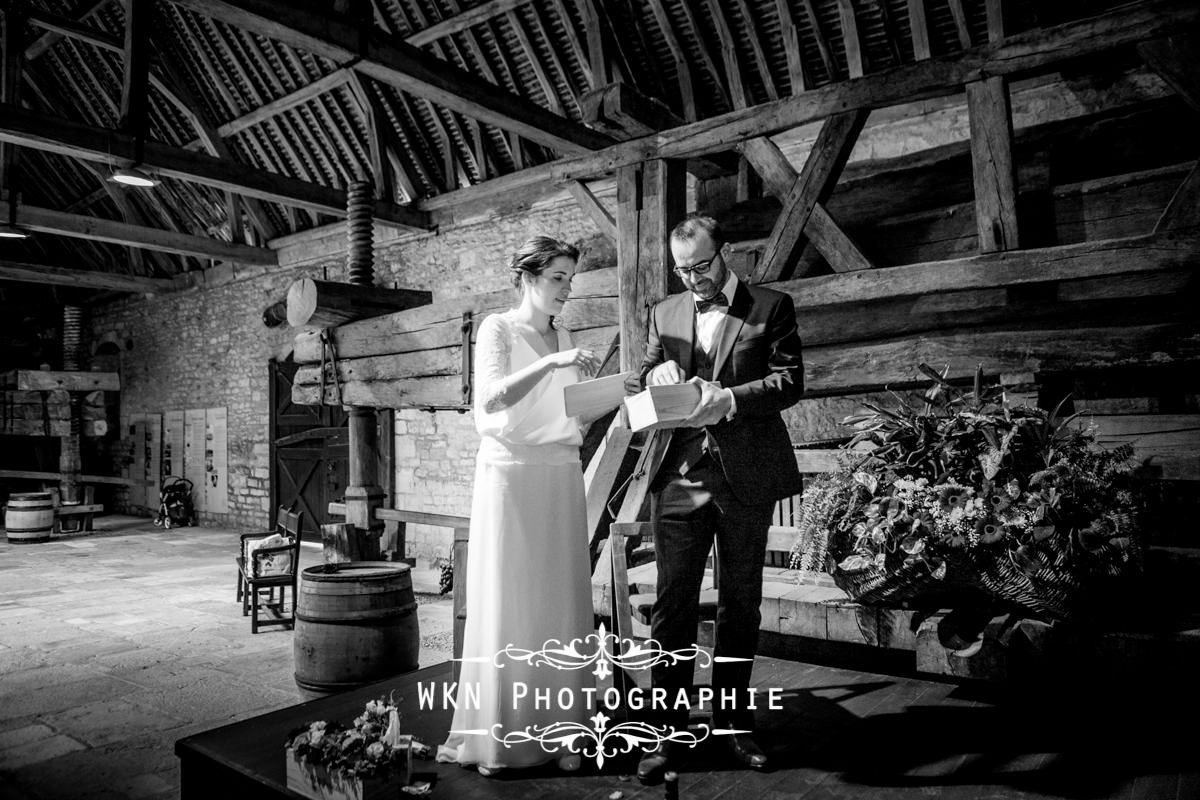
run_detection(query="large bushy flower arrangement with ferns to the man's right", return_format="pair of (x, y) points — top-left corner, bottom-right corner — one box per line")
(792, 365), (1142, 616)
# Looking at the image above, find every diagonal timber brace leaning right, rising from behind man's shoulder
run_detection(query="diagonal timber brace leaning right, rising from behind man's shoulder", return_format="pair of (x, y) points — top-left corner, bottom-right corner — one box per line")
(750, 110), (868, 283)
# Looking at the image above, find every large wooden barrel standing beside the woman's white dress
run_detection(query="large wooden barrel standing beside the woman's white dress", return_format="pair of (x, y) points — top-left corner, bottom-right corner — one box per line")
(293, 561), (421, 694)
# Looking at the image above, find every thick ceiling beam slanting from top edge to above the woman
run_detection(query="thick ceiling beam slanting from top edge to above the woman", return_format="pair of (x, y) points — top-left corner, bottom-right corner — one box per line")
(169, 0), (611, 154)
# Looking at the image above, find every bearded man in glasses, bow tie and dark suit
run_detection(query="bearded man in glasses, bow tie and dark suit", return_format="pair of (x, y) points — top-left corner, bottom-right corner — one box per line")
(637, 216), (804, 781)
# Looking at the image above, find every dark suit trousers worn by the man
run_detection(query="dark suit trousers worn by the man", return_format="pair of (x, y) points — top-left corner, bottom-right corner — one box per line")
(650, 453), (774, 730)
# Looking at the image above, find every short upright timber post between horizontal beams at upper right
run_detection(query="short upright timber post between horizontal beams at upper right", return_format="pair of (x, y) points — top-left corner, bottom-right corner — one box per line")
(967, 77), (1020, 253)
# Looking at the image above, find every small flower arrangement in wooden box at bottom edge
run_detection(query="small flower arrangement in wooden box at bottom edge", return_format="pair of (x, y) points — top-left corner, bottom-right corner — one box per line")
(287, 697), (413, 796)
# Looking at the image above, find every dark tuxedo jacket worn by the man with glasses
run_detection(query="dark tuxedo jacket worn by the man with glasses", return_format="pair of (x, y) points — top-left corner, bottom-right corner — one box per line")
(641, 281), (804, 503)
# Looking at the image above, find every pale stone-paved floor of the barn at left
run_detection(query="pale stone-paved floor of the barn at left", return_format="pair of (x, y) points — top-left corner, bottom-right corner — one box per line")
(0, 516), (452, 800)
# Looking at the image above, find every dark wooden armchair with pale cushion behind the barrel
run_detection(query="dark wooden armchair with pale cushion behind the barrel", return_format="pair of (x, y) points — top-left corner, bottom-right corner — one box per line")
(236, 507), (304, 633)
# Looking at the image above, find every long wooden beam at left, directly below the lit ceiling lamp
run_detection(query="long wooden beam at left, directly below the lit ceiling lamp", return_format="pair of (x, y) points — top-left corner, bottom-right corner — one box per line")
(0, 201), (278, 266)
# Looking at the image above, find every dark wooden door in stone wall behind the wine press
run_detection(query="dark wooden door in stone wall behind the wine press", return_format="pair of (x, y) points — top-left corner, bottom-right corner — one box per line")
(270, 360), (350, 542)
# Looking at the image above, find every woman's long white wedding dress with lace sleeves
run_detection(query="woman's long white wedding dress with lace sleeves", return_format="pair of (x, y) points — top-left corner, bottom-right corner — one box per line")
(438, 312), (595, 768)
